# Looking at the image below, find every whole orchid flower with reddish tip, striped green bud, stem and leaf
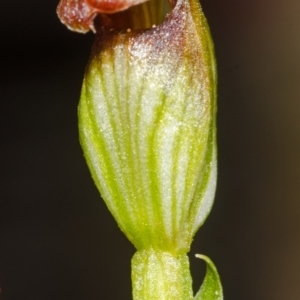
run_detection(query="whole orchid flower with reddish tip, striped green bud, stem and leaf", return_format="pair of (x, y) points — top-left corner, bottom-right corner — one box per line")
(57, 0), (223, 300)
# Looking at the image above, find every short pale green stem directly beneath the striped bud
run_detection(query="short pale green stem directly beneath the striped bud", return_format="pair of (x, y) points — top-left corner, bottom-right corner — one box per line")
(131, 249), (193, 300)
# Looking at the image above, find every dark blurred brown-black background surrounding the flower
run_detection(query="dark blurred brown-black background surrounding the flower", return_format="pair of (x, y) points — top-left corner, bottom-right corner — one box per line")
(0, 0), (300, 300)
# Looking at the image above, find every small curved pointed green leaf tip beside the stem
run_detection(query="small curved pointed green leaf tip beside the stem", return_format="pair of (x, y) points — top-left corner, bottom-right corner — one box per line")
(194, 254), (223, 300)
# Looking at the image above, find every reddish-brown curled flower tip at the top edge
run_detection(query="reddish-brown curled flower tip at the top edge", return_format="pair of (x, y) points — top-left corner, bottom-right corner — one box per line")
(57, 0), (147, 33)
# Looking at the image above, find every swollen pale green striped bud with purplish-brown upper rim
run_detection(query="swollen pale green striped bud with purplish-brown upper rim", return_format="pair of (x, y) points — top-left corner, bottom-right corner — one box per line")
(79, 0), (216, 253)
